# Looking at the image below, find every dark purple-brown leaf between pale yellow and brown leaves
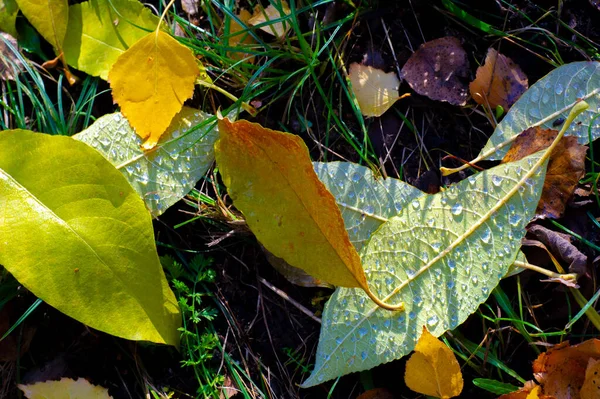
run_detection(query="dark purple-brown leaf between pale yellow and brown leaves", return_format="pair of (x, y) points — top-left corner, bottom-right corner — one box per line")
(402, 36), (469, 105)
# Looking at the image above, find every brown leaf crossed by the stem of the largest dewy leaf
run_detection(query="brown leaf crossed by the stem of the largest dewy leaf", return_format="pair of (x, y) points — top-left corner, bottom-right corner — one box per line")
(502, 126), (587, 219)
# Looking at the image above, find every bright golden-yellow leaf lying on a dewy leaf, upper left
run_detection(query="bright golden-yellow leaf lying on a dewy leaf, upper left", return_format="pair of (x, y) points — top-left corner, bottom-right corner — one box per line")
(108, 31), (200, 150)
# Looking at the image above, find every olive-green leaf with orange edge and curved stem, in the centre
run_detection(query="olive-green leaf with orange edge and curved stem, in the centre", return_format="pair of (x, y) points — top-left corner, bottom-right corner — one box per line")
(215, 119), (402, 309)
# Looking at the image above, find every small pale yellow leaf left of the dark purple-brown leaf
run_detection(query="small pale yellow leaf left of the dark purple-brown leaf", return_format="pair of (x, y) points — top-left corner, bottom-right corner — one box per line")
(349, 63), (401, 116)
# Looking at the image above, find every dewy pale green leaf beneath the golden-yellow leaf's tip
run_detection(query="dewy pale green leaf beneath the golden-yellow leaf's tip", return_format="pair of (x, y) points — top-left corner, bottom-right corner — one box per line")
(73, 107), (219, 217)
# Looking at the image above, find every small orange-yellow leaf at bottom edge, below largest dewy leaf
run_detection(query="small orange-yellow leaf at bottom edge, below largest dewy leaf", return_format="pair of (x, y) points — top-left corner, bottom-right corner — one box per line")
(404, 327), (463, 398)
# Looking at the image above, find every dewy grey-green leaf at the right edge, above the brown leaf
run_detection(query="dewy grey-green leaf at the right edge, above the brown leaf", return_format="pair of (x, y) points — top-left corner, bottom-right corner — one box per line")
(478, 61), (600, 160)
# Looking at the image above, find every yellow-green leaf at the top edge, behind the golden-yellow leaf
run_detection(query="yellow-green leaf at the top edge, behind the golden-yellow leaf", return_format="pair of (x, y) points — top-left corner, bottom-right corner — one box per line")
(63, 0), (158, 80)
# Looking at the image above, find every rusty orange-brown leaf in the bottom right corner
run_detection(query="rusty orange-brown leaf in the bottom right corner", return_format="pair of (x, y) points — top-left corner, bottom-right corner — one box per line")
(533, 338), (600, 399)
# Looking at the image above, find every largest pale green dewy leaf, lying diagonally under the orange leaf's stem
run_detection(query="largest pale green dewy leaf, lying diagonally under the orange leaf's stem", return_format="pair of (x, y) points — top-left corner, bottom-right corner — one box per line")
(303, 153), (546, 387)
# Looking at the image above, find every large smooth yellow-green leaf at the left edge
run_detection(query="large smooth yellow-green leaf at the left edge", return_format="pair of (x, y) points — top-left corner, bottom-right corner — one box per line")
(0, 130), (181, 345)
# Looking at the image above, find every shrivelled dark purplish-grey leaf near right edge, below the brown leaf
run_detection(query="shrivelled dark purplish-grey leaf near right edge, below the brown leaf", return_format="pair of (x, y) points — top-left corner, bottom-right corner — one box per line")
(527, 225), (587, 275)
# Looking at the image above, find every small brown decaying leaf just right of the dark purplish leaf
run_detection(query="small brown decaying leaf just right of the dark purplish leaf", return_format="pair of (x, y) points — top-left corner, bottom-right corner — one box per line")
(469, 48), (529, 110)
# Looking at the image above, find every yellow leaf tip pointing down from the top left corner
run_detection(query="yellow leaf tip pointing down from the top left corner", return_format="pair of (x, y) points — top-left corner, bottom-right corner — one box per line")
(17, 0), (69, 54)
